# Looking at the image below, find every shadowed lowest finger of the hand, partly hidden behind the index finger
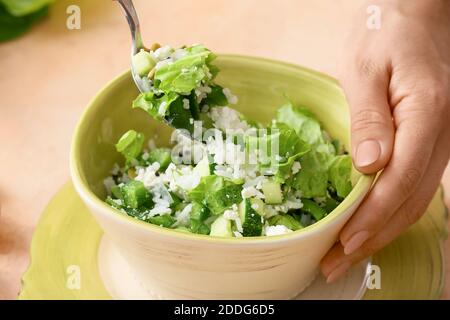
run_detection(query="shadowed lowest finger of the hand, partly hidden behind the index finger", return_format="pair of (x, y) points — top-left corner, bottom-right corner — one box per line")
(321, 133), (450, 282)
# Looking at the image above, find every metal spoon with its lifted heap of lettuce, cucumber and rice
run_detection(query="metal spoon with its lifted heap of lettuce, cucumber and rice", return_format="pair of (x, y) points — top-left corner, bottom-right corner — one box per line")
(117, 0), (232, 134)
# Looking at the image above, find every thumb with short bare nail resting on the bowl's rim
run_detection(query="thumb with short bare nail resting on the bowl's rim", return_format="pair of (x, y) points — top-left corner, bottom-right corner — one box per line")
(342, 61), (394, 173)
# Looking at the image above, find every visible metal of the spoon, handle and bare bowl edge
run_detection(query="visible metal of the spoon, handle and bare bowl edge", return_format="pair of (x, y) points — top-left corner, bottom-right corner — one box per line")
(116, 0), (149, 92)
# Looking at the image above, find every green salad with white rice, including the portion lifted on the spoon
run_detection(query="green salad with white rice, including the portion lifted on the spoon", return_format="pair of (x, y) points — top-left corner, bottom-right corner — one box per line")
(104, 45), (352, 238)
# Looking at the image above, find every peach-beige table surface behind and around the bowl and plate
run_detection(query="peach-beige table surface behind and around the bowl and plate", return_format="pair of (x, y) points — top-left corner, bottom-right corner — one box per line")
(0, 0), (450, 299)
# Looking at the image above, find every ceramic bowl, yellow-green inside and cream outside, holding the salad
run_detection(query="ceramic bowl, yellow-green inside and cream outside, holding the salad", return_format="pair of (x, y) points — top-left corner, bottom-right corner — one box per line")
(71, 55), (374, 299)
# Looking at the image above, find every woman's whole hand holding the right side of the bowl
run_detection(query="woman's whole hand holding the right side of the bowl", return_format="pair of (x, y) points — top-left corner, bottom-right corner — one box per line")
(321, 0), (450, 282)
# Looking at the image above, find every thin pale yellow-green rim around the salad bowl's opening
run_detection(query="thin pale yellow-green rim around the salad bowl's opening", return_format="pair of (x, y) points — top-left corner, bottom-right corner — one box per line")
(70, 54), (376, 245)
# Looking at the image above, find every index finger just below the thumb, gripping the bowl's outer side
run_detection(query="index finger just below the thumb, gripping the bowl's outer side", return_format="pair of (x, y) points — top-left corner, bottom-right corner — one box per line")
(340, 100), (440, 254)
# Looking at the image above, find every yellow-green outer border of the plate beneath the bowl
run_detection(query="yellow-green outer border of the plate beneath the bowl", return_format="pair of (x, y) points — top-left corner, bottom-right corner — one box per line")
(19, 183), (447, 299)
